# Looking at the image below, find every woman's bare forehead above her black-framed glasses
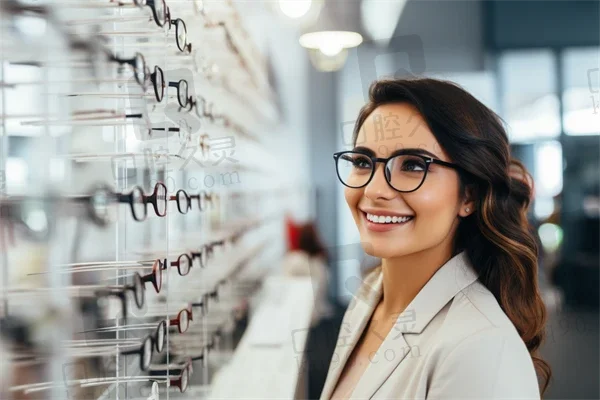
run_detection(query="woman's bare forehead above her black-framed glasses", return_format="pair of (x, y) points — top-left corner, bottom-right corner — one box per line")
(355, 103), (447, 160)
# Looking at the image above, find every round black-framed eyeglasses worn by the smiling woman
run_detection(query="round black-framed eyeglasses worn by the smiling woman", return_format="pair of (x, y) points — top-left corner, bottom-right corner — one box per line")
(333, 149), (460, 193)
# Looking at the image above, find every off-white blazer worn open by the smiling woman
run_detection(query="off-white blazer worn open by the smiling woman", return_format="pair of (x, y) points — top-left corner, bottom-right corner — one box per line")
(320, 252), (540, 400)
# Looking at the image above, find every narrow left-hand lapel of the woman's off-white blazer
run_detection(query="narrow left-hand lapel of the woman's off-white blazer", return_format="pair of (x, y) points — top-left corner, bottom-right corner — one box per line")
(320, 268), (383, 400)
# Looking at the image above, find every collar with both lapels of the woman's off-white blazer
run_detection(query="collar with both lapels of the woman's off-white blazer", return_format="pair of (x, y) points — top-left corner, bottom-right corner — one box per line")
(321, 252), (477, 400)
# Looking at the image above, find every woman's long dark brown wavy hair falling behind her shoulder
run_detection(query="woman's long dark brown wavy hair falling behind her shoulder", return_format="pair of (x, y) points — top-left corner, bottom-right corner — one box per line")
(353, 78), (552, 395)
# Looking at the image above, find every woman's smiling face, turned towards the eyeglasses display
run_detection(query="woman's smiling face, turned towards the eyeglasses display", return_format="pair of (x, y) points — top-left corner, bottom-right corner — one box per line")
(344, 103), (473, 258)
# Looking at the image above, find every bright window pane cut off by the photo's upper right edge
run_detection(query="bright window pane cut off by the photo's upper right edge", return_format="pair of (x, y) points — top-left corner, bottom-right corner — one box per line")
(562, 47), (600, 135)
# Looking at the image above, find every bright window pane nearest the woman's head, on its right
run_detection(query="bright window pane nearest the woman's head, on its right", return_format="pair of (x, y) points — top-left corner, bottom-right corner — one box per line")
(499, 50), (560, 142)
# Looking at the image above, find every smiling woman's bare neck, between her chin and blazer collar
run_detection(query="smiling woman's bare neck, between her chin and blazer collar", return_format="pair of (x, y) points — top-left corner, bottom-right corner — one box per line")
(380, 246), (453, 315)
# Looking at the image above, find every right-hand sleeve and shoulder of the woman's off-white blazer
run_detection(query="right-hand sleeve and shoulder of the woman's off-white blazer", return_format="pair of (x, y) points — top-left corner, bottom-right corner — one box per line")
(427, 281), (540, 400)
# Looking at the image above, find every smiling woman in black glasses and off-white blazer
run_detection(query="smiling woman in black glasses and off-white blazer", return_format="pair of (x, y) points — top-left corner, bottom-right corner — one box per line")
(321, 79), (550, 400)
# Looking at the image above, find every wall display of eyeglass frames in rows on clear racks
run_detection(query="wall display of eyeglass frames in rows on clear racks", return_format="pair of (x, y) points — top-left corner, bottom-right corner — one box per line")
(0, 0), (297, 400)
